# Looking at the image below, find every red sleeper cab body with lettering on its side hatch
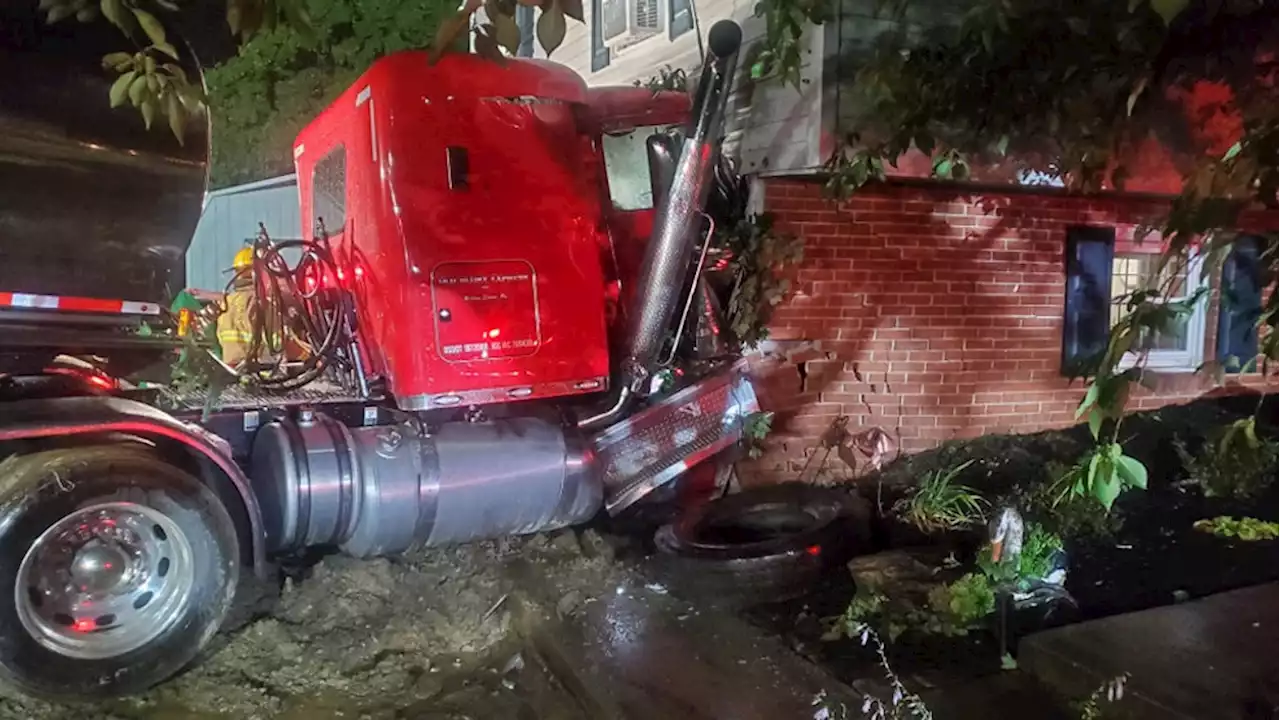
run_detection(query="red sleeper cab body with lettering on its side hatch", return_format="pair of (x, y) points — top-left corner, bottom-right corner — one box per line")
(294, 53), (619, 407)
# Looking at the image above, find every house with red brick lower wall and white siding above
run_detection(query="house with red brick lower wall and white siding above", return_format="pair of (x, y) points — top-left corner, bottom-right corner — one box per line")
(512, 0), (1280, 477)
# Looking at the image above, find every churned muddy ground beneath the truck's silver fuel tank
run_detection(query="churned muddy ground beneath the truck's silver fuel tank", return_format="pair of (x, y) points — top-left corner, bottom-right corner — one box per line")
(0, 532), (626, 720)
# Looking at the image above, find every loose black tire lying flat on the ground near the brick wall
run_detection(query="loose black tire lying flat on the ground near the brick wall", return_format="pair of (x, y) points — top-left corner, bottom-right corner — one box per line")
(654, 483), (856, 607)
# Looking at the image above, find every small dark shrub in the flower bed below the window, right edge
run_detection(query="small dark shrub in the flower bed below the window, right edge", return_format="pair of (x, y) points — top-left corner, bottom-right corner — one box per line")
(1174, 418), (1280, 500)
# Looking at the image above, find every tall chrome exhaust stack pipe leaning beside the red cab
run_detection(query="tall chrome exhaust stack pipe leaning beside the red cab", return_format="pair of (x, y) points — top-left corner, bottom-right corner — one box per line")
(579, 20), (742, 428)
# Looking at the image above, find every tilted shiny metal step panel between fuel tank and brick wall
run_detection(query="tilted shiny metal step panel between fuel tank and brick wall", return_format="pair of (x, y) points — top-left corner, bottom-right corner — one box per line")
(593, 363), (759, 515)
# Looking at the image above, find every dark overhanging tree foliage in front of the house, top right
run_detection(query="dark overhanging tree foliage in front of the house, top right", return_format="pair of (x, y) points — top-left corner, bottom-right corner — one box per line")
(827, 0), (1280, 515)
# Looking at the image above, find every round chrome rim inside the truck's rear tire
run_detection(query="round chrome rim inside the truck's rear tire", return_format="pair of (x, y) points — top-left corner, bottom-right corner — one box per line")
(14, 502), (196, 660)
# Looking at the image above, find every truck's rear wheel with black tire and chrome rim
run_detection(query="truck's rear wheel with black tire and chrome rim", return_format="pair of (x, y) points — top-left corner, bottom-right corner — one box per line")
(0, 446), (239, 698)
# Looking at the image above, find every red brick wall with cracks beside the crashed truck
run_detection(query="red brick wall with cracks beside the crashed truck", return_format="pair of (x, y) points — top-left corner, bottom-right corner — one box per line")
(754, 179), (1280, 475)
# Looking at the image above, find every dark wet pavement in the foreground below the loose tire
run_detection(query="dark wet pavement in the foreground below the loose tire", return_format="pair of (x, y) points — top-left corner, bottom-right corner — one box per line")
(509, 556), (861, 720)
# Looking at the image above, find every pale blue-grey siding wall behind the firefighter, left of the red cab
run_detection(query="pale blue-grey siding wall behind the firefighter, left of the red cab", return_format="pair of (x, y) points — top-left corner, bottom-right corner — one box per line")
(187, 176), (302, 292)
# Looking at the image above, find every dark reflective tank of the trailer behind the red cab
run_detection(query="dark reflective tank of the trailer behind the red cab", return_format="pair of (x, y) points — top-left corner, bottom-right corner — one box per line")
(0, 0), (209, 302)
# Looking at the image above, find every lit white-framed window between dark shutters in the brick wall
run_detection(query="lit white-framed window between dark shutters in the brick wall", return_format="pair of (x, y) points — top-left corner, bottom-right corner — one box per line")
(1108, 252), (1206, 370)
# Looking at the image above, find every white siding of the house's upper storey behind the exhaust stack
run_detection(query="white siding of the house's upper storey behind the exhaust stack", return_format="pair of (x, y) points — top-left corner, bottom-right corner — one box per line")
(550, 0), (835, 174)
